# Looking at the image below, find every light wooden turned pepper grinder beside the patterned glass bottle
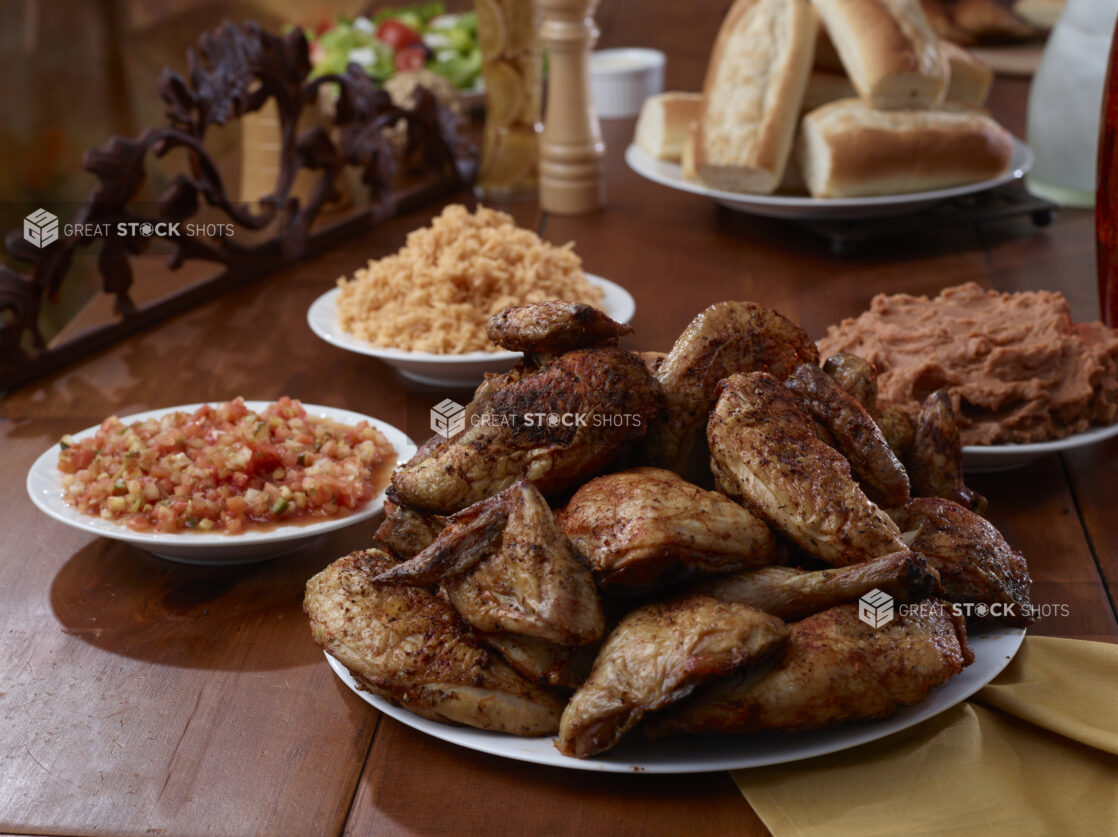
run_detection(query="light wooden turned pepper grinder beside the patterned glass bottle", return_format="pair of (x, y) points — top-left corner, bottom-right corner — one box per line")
(537, 0), (606, 215)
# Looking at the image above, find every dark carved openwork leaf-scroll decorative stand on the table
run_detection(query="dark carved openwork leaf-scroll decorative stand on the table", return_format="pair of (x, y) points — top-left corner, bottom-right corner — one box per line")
(0, 21), (476, 391)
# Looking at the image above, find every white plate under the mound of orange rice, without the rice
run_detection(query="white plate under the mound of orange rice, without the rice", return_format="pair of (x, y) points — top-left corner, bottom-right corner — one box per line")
(306, 274), (636, 389)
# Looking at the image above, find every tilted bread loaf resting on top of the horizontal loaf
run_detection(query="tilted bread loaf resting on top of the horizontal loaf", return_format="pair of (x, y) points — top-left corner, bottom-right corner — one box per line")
(814, 0), (947, 110)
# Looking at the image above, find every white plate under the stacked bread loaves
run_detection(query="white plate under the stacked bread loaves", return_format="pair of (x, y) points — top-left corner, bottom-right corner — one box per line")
(625, 137), (1033, 220)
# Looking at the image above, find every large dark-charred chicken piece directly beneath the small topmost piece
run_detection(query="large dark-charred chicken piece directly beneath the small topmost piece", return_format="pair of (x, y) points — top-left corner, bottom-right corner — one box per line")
(392, 348), (662, 513)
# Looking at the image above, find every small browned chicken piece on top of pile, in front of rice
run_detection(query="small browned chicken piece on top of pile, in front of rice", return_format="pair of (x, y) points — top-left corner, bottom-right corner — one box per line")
(485, 299), (633, 354)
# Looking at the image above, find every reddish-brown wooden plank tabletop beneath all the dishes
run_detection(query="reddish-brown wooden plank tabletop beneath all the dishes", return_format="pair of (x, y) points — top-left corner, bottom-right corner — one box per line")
(0, 3), (1118, 835)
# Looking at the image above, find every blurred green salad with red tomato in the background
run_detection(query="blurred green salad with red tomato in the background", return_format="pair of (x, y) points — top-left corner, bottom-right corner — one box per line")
(306, 2), (482, 89)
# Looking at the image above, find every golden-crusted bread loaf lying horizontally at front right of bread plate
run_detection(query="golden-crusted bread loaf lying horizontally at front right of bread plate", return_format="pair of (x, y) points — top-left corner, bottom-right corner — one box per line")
(797, 98), (1013, 198)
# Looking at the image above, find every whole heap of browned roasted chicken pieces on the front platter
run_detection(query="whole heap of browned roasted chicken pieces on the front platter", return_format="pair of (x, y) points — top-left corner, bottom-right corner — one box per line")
(305, 303), (1029, 758)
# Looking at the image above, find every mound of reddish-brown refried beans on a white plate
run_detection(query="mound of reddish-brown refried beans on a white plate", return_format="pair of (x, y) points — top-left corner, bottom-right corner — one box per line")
(818, 283), (1118, 445)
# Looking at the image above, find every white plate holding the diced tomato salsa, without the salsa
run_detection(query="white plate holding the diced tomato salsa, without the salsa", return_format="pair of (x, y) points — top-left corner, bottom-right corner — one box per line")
(27, 401), (416, 564)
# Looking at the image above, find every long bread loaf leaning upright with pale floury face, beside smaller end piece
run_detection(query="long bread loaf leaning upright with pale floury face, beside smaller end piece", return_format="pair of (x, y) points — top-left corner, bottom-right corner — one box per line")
(695, 0), (818, 194)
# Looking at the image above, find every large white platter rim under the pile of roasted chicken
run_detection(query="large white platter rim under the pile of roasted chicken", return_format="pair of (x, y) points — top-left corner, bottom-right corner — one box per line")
(326, 628), (1025, 773)
